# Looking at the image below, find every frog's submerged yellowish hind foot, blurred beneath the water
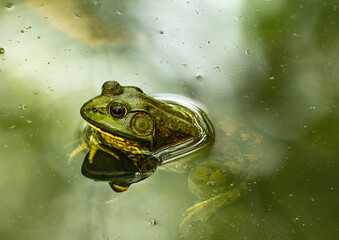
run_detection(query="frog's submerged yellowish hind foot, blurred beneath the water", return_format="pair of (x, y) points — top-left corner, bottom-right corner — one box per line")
(179, 182), (248, 228)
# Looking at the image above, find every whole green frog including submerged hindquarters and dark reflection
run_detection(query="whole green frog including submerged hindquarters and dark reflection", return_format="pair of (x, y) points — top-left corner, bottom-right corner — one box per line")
(70, 81), (261, 224)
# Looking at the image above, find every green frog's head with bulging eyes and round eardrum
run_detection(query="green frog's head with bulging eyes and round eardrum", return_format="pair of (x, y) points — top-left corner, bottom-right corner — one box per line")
(80, 81), (155, 150)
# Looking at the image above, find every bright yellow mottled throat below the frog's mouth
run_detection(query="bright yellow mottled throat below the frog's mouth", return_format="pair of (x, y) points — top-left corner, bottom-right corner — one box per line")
(87, 122), (141, 153)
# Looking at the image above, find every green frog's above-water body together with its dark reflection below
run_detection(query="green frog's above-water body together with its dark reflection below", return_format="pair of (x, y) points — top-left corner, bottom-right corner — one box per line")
(70, 81), (214, 192)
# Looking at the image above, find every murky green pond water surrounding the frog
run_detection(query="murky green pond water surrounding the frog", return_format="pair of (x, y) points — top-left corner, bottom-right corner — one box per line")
(0, 0), (339, 239)
